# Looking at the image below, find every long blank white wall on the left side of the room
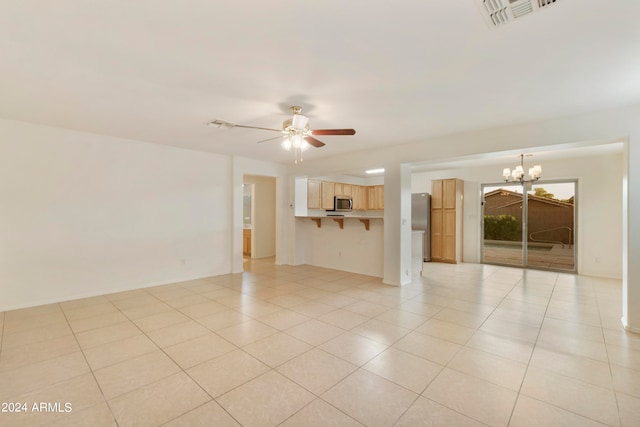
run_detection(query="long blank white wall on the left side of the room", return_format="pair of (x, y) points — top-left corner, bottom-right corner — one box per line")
(0, 120), (231, 311)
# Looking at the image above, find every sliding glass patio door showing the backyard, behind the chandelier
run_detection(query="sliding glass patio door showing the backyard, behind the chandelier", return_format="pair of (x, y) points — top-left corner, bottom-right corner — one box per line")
(481, 181), (577, 272)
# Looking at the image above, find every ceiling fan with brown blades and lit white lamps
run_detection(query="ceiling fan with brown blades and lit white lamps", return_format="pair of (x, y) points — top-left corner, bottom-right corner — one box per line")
(208, 106), (356, 163)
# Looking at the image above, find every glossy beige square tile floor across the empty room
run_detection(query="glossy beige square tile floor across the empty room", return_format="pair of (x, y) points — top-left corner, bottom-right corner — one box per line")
(0, 259), (640, 427)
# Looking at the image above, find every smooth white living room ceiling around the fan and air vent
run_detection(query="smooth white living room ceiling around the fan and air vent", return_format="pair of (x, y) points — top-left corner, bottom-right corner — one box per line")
(0, 0), (640, 163)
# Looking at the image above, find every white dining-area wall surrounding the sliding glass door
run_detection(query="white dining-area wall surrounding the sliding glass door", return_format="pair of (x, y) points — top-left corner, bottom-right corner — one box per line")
(411, 153), (623, 279)
